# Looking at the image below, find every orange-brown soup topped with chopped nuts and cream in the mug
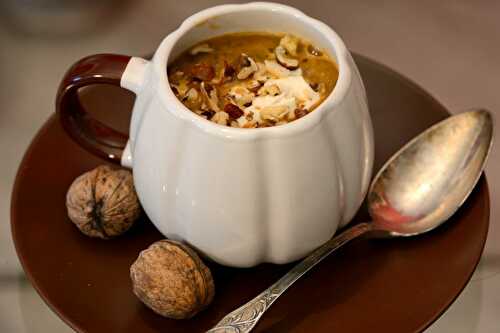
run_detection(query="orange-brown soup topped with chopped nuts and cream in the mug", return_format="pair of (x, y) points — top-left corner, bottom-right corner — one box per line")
(168, 33), (338, 128)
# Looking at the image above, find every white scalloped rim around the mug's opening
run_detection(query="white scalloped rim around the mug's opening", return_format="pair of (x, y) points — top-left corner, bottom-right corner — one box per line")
(153, 2), (352, 140)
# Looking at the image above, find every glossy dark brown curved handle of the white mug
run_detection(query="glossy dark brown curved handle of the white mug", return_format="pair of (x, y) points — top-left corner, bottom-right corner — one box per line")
(56, 54), (131, 163)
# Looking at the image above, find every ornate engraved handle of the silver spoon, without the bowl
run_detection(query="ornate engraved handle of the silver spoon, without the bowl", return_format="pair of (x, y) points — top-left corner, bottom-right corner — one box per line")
(207, 223), (372, 333)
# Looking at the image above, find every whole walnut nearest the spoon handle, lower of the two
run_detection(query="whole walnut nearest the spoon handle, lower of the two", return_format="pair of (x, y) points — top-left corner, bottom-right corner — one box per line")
(130, 240), (215, 319)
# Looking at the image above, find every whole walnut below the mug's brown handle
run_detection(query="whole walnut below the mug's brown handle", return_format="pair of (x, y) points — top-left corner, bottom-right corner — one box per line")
(66, 165), (141, 239)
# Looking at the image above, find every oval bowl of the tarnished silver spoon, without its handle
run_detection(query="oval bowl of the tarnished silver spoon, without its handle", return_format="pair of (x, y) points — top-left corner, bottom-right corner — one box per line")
(367, 110), (493, 236)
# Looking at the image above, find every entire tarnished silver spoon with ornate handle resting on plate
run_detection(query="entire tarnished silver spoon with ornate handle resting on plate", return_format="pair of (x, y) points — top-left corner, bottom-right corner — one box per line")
(208, 110), (493, 333)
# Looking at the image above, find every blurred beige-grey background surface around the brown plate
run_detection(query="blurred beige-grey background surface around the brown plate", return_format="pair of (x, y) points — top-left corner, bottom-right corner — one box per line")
(0, 0), (500, 333)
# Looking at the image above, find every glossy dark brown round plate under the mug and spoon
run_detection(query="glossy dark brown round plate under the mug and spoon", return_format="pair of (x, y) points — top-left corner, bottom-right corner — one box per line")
(12, 56), (489, 333)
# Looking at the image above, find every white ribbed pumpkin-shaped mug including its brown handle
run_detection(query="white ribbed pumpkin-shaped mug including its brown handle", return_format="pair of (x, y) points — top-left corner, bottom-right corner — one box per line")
(57, 2), (373, 267)
